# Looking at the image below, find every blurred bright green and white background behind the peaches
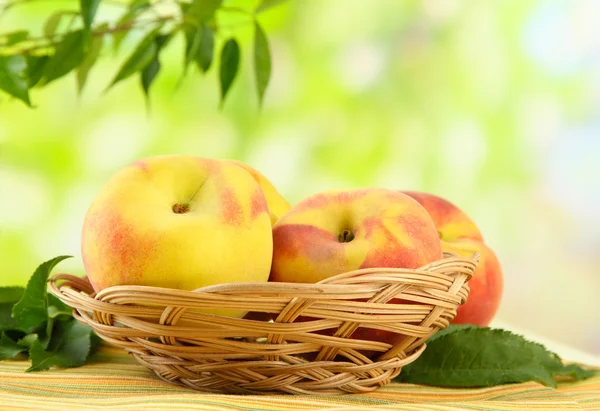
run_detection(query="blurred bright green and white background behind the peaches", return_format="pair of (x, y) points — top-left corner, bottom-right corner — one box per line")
(0, 0), (600, 355)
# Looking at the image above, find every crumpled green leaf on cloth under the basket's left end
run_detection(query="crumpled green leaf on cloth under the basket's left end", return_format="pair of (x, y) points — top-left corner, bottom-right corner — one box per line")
(26, 321), (94, 372)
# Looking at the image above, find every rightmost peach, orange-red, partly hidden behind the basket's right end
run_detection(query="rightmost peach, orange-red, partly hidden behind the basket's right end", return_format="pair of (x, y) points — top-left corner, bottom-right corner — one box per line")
(403, 191), (503, 326)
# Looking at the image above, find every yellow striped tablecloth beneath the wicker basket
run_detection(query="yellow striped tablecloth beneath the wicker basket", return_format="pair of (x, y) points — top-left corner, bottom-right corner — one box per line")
(0, 346), (600, 411)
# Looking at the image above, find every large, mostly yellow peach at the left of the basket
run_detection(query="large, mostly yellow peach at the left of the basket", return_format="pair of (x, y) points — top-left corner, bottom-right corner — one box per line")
(81, 155), (273, 315)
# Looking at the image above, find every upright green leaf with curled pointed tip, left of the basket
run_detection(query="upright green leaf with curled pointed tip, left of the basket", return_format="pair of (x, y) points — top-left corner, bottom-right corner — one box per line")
(12, 256), (71, 330)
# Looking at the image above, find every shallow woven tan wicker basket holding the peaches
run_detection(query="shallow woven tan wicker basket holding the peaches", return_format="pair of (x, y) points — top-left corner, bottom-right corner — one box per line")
(49, 254), (479, 395)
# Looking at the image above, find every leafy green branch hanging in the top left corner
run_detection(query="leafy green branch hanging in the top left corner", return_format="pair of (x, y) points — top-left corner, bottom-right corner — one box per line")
(0, 0), (285, 107)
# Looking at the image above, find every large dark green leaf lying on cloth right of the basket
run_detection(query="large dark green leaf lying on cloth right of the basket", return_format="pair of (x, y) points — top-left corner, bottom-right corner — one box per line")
(397, 326), (588, 387)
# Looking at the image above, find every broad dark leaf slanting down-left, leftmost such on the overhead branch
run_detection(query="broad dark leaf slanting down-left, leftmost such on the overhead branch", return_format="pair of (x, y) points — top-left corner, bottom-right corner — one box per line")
(44, 30), (86, 84)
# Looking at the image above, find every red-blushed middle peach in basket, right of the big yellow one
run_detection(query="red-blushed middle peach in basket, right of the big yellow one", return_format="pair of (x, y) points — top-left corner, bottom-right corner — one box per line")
(270, 188), (442, 360)
